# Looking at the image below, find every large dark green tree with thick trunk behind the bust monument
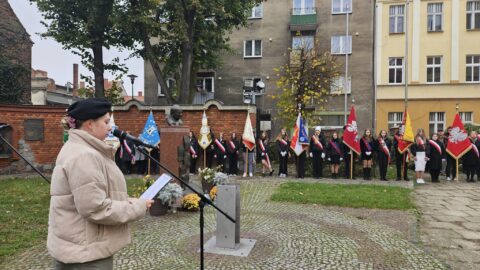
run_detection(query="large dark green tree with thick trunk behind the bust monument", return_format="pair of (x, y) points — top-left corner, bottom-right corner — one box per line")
(123, 0), (261, 104)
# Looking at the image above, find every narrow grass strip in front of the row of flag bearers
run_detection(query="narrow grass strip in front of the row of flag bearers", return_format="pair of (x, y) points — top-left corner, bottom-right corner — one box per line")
(271, 182), (414, 210)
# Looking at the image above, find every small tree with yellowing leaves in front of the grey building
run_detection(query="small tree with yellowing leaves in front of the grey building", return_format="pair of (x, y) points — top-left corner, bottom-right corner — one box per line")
(271, 39), (339, 126)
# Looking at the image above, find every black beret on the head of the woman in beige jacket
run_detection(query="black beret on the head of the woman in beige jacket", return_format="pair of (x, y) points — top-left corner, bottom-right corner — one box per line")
(67, 98), (112, 120)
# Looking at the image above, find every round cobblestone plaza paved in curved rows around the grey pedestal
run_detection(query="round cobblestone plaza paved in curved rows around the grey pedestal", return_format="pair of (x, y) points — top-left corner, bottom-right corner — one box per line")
(0, 178), (448, 270)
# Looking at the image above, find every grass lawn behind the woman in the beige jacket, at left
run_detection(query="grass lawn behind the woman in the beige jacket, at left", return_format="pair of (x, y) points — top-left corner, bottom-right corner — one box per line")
(0, 178), (142, 262)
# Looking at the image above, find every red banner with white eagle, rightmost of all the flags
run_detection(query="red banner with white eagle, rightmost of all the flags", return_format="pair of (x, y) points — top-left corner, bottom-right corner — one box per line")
(447, 113), (472, 159)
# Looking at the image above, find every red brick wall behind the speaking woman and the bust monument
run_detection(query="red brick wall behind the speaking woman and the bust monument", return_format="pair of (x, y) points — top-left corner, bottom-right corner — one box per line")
(0, 105), (256, 174)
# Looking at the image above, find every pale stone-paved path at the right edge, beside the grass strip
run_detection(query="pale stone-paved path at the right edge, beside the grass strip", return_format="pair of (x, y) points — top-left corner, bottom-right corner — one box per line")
(415, 182), (480, 270)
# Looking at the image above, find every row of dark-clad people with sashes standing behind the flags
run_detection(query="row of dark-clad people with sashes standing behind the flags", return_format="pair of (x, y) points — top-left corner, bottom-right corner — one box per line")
(189, 127), (480, 183)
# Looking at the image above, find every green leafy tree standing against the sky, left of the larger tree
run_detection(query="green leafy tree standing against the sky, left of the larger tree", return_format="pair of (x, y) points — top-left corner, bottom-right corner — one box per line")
(30, 0), (133, 97)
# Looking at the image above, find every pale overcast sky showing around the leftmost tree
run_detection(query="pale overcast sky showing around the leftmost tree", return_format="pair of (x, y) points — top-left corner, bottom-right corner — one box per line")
(8, 0), (144, 95)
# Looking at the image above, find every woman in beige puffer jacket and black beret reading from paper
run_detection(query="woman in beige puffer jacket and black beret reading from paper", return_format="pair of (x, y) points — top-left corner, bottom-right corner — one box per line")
(47, 98), (153, 269)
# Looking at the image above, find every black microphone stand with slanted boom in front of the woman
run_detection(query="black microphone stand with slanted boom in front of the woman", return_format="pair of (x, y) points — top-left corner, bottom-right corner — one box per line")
(135, 145), (236, 270)
